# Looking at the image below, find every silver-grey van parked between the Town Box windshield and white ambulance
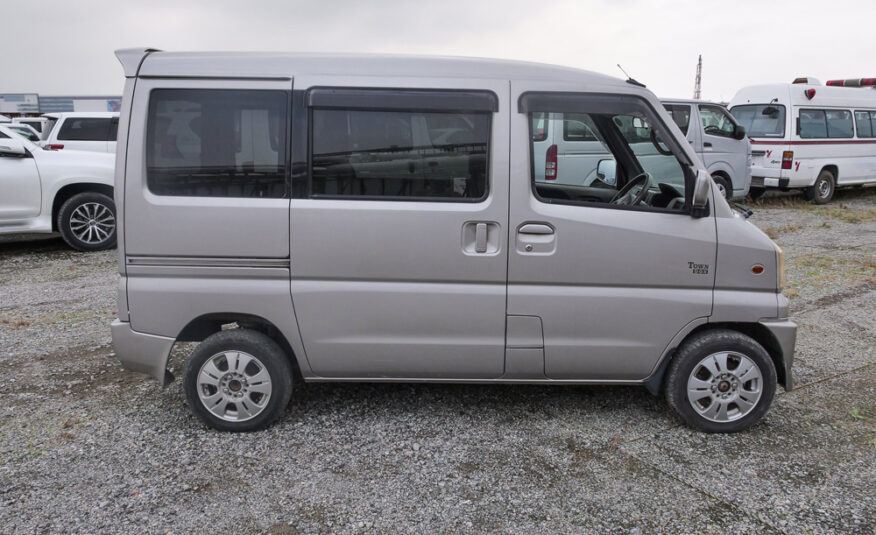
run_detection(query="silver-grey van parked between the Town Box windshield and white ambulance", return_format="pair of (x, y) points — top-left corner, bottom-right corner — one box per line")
(661, 99), (751, 199)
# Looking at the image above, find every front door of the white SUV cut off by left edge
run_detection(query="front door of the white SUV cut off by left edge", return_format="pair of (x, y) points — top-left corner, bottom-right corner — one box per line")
(0, 137), (42, 225)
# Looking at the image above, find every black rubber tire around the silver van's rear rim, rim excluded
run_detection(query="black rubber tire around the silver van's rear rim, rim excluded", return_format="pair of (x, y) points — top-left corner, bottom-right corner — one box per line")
(183, 329), (292, 432)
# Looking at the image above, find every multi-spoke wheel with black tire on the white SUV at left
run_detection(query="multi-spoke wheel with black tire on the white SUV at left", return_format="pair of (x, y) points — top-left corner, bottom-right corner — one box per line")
(57, 191), (116, 252)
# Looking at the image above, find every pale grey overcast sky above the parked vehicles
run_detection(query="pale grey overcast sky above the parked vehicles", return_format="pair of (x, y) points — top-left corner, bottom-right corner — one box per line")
(0, 0), (876, 100)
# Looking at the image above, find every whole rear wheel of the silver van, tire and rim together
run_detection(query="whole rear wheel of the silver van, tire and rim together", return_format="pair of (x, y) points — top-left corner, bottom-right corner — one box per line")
(183, 329), (292, 432)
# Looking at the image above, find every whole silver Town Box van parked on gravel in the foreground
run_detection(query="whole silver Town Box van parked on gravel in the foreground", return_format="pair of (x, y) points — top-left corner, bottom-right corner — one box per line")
(112, 49), (796, 432)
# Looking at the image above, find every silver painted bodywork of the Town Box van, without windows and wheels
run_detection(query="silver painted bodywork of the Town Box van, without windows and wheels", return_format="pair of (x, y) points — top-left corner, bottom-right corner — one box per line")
(113, 50), (796, 392)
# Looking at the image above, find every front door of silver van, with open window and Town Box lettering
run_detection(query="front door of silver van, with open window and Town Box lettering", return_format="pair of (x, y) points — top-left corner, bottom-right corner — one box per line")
(508, 84), (716, 380)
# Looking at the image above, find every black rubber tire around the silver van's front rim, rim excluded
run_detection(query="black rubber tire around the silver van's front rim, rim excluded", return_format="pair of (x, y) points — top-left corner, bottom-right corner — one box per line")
(664, 329), (776, 433)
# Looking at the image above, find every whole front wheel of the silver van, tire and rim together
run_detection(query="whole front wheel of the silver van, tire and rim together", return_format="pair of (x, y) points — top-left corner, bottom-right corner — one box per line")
(665, 329), (776, 433)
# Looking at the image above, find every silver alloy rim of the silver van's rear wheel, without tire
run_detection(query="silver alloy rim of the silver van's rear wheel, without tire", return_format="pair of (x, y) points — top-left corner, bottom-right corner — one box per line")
(197, 351), (272, 422)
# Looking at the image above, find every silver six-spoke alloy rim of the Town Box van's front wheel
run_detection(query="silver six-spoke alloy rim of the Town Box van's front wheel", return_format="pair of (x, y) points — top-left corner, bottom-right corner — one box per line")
(687, 351), (763, 422)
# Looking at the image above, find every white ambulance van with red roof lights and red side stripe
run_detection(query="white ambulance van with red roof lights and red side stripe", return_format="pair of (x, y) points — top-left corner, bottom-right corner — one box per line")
(730, 78), (876, 204)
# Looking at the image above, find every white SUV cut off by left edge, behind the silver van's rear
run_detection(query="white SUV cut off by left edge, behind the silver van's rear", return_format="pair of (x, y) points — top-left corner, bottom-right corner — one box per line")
(0, 124), (116, 251)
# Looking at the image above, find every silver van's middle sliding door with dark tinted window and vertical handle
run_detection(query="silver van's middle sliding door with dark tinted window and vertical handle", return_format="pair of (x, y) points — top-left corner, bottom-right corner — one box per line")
(290, 84), (509, 378)
